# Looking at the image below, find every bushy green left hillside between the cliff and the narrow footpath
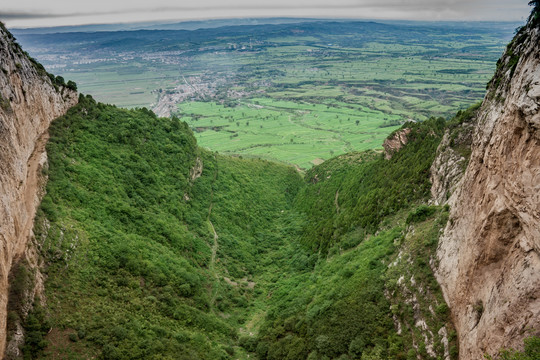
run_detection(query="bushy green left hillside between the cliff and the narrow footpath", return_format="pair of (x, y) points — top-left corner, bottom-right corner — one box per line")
(36, 97), (221, 359)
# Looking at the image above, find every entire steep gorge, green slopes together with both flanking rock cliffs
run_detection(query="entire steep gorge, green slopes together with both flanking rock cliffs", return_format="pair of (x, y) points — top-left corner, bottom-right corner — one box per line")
(0, 11), (540, 359)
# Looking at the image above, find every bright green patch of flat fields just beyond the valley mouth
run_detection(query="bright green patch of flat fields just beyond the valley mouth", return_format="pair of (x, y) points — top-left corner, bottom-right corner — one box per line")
(179, 98), (399, 168)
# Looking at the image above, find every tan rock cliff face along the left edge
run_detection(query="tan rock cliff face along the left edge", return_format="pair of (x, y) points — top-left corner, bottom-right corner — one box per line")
(0, 26), (77, 358)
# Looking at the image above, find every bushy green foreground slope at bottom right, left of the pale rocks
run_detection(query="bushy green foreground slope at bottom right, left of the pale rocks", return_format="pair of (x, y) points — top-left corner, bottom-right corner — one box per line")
(255, 227), (402, 359)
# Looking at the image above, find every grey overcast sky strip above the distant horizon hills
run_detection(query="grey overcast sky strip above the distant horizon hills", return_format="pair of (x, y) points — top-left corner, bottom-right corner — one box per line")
(0, 0), (530, 27)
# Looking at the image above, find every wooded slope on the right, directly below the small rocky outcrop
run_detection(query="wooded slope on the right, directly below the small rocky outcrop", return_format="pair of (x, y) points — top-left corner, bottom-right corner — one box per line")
(298, 119), (445, 253)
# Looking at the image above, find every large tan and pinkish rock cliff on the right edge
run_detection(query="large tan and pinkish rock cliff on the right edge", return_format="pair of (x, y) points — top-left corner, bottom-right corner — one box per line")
(435, 24), (540, 359)
